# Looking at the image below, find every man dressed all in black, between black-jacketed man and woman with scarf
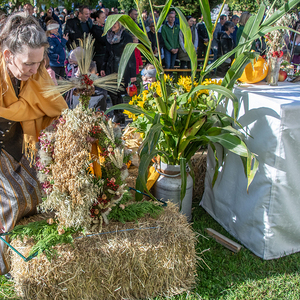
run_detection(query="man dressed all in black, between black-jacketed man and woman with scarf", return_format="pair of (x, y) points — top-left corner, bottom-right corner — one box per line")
(91, 10), (106, 71)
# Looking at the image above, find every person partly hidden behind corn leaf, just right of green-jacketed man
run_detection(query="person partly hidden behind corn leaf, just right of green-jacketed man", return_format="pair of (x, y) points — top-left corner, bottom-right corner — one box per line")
(178, 16), (198, 69)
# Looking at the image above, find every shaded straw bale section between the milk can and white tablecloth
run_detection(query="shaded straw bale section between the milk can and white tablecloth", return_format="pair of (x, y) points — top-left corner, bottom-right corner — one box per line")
(191, 151), (207, 199)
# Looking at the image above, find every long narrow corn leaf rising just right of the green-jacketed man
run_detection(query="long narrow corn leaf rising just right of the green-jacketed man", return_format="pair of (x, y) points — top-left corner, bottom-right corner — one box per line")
(174, 7), (197, 81)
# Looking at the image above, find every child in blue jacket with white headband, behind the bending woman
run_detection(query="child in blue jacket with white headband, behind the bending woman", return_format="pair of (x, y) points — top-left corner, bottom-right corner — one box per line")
(46, 20), (69, 79)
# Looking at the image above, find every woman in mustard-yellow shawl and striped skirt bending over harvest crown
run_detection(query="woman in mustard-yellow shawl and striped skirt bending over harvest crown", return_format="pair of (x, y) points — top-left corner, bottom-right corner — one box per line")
(0, 13), (67, 274)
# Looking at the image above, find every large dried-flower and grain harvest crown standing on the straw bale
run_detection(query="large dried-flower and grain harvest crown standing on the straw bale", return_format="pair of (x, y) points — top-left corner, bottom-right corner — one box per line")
(36, 104), (129, 230)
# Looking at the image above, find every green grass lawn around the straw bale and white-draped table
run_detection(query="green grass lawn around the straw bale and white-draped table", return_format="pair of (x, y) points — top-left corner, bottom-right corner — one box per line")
(0, 201), (300, 300)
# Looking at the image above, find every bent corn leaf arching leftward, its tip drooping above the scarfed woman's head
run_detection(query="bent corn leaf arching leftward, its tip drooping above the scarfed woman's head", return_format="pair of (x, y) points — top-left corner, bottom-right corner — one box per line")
(103, 14), (151, 49)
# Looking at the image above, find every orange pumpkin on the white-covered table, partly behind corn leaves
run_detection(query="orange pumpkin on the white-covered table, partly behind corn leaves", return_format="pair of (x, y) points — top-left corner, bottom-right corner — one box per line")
(239, 56), (269, 83)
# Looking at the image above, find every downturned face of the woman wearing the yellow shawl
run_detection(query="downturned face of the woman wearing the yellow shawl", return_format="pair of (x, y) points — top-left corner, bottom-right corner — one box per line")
(3, 46), (45, 81)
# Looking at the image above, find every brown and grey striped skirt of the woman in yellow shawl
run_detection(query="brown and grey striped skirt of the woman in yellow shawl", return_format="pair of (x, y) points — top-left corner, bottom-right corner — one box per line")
(0, 151), (41, 275)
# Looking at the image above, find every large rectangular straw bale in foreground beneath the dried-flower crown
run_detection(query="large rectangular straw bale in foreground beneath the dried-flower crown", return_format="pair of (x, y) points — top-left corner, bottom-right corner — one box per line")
(10, 203), (197, 300)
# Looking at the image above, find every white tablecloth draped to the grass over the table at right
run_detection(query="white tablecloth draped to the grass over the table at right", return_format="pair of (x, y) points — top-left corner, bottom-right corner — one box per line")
(200, 82), (300, 259)
